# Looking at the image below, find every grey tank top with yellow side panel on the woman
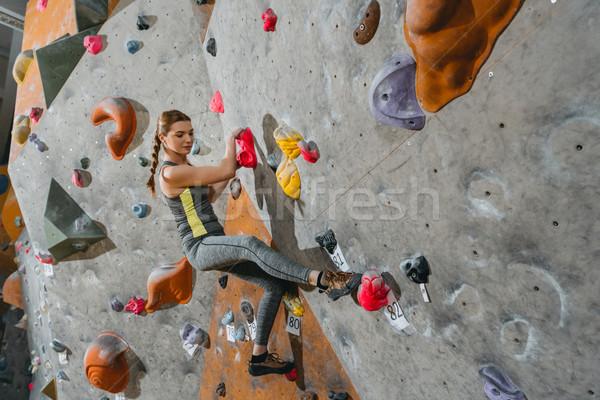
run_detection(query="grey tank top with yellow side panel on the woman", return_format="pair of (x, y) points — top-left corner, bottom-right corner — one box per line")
(159, 161), (225, 239)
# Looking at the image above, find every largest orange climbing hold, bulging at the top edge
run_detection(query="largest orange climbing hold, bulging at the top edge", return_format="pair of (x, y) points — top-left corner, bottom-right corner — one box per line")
(404, 0), (523, 112)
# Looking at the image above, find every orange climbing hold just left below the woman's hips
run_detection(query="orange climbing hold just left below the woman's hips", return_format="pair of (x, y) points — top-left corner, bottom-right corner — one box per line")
(146, 257), (192, 313)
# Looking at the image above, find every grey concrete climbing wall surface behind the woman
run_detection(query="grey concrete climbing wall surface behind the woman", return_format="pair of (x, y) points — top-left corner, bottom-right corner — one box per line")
(9, 0), (600, 400)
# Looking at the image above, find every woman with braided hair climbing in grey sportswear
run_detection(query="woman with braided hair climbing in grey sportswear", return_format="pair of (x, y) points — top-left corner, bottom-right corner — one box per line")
(146, 110), (361, 376)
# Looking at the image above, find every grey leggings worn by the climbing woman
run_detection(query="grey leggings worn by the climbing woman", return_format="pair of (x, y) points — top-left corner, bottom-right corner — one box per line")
(183, 236), (311, 346)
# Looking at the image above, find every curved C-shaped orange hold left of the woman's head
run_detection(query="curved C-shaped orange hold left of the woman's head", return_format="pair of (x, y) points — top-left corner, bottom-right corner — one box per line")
(92, 97), (137, 160)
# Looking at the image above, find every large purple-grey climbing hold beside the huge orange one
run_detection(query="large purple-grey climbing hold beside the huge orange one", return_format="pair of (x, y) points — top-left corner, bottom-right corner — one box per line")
(369, 53), (425, 130)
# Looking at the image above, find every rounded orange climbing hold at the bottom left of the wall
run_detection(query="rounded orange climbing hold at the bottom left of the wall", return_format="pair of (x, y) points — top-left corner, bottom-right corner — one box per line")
(84, 332), (129, 393)
